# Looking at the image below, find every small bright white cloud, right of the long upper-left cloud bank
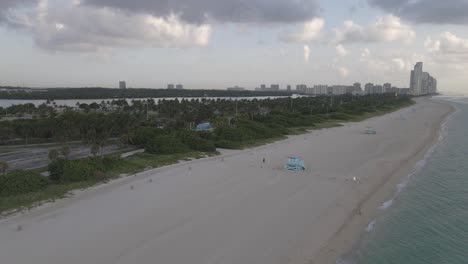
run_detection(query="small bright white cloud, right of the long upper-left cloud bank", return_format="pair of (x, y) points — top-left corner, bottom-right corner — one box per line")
(280, 18), (325, 43)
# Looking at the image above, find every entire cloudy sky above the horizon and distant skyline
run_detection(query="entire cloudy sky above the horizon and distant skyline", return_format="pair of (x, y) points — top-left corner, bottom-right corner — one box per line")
(0, 0), (468, 94)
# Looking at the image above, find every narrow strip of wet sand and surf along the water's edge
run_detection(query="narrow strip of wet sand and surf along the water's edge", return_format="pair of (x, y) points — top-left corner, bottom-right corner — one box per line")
(309, 98), (456, 264)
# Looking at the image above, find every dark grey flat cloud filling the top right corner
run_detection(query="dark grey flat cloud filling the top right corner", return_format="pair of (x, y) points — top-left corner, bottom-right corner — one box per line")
(368, 0), (468, 24)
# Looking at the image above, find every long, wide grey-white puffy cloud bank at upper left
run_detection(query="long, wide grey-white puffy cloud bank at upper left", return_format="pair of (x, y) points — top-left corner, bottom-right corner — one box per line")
(3, 0), (212, 52)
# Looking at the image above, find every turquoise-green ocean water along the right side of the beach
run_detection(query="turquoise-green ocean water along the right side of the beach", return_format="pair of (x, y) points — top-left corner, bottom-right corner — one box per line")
(348, 97), (468, 264)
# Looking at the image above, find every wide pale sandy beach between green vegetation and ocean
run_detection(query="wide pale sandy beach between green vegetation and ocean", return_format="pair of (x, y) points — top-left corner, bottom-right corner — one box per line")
(0, 98), (453, 264)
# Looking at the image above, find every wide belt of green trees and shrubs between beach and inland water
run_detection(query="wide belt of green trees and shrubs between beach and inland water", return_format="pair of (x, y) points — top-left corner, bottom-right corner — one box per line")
(0, 94), (413, 212)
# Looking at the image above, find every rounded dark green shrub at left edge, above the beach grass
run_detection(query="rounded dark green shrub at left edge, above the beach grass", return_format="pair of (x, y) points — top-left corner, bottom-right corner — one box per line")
(0, 170), (48, 197)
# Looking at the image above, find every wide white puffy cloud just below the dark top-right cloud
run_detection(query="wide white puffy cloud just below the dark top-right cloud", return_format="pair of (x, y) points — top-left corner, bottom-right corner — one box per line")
(335, 15), (416, 43)
